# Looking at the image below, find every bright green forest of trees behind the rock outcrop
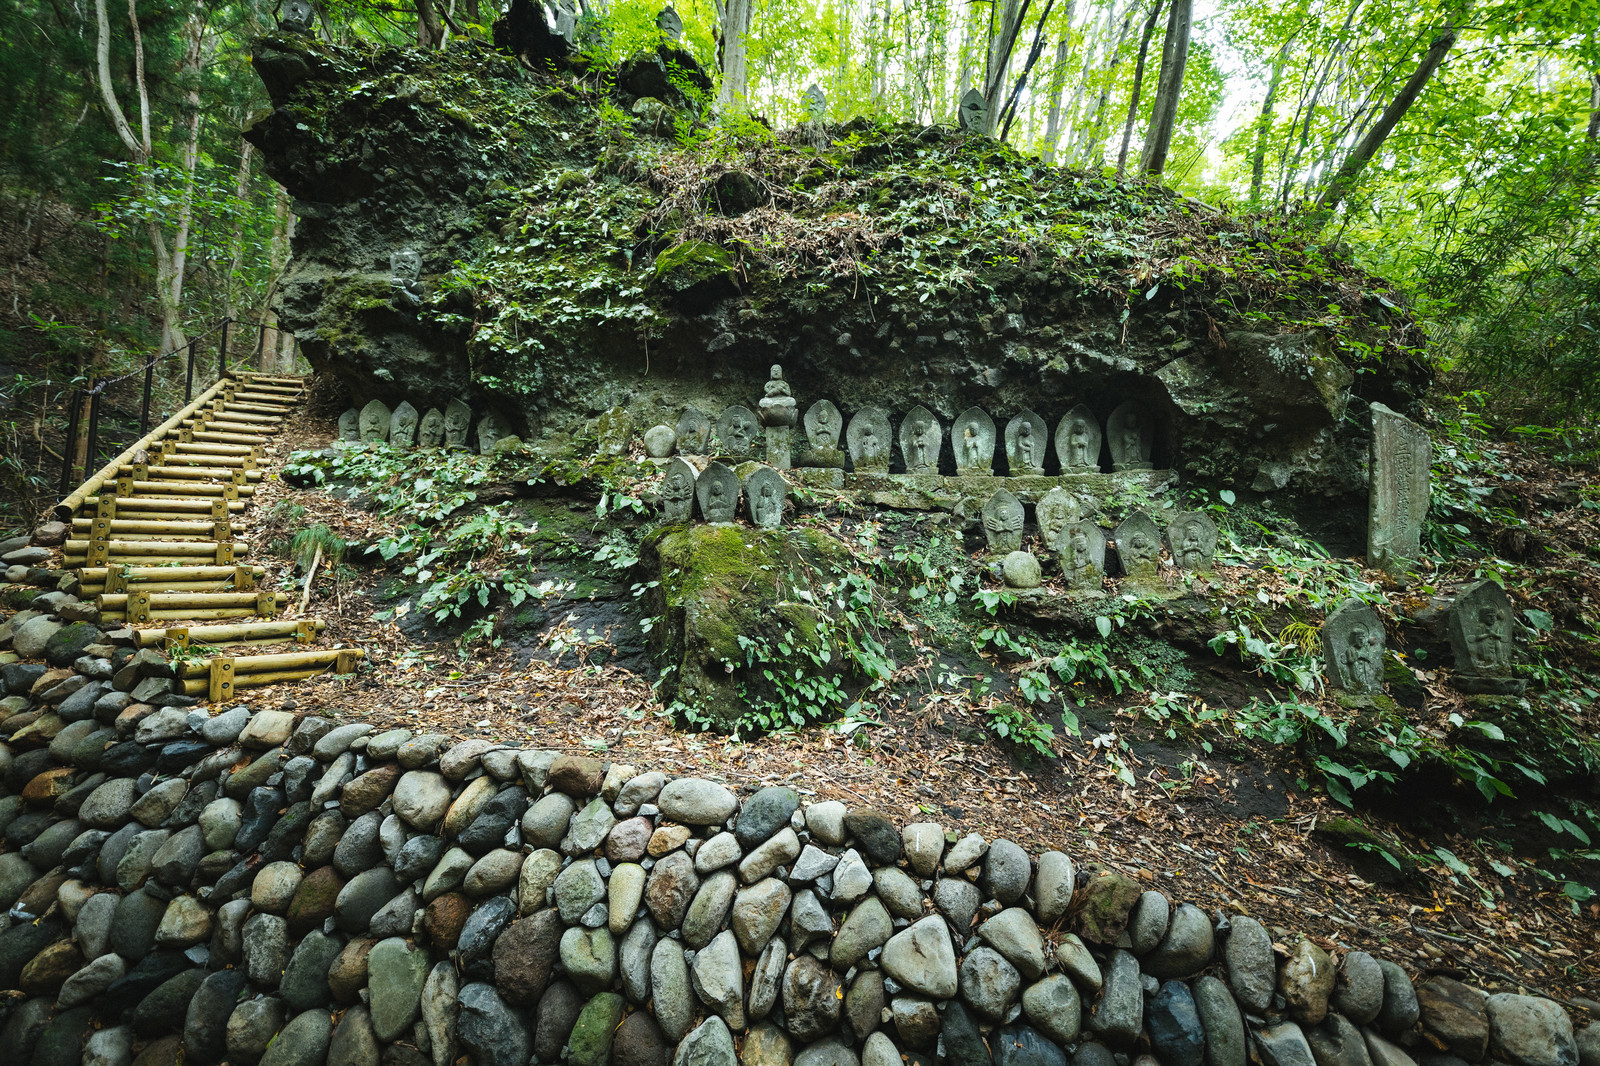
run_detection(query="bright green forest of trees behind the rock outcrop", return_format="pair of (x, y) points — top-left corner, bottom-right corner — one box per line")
(0, 0), (1600, 527)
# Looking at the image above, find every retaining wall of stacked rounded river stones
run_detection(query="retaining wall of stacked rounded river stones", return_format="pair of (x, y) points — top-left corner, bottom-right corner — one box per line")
(0, 634), (1600, 1066)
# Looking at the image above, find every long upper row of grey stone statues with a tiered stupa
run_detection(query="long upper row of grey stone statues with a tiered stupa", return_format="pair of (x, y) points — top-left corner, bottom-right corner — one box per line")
(645, 367), (1155, 477)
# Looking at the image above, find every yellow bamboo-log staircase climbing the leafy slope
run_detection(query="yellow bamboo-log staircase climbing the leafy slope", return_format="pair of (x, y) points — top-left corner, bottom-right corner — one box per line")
(56, 371), (362, 703)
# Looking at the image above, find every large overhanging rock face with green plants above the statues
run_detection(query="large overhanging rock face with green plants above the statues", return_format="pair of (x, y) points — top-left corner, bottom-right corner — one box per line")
(246, 32), (1426, 525)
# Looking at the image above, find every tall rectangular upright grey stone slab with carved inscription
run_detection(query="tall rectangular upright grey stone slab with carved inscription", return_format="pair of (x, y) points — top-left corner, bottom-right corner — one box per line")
(1366, 403), (1434, 575)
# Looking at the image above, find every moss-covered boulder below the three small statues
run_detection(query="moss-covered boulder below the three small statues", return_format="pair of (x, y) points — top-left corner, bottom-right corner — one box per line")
(642, 525), (850, 731)
